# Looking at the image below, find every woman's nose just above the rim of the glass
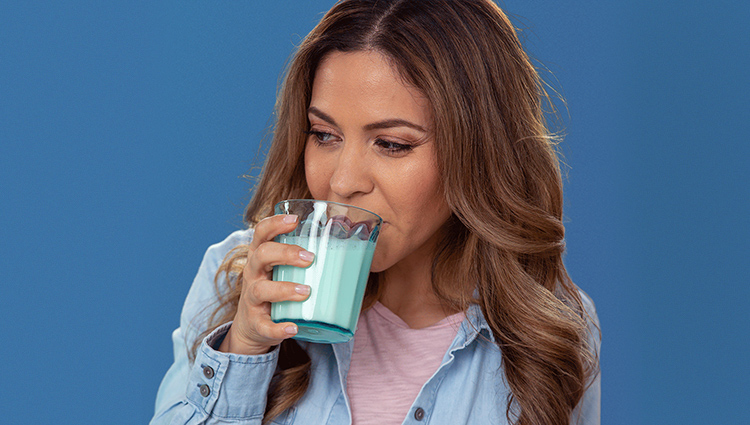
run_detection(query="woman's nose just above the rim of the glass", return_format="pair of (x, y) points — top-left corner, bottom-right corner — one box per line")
(330, 142), (374, 200)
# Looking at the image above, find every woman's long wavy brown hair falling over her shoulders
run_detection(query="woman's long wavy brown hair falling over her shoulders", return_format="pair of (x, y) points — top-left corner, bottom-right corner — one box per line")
(193, 0), (598, 425)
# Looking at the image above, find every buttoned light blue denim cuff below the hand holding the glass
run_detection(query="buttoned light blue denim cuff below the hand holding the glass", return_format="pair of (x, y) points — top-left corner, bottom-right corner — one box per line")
(187, 322), (279, 420)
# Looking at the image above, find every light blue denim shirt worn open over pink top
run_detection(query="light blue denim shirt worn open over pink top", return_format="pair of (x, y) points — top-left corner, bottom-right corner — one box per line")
(151, 230), (601, 425)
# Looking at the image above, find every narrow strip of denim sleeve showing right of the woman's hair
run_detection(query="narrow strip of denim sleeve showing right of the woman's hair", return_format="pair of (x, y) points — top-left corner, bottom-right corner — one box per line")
(571, 291), (602, 425)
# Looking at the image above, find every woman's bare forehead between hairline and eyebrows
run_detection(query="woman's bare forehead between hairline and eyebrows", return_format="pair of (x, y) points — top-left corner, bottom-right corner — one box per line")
(310, 51), (431, 127)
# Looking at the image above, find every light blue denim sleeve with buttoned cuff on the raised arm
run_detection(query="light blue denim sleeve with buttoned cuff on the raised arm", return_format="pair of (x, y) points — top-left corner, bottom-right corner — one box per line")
(150, 230), (278, 425)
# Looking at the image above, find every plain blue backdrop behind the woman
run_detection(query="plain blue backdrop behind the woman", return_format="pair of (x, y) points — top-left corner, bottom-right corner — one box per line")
(0, 0), (750, 424)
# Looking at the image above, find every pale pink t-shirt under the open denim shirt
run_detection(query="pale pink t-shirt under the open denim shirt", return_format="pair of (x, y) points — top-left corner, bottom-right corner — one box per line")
(346, 302), (464, 425)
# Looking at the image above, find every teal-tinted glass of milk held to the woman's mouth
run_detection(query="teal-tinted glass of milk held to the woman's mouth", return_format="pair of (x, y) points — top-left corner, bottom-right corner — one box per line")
(271, 199), (383, 343)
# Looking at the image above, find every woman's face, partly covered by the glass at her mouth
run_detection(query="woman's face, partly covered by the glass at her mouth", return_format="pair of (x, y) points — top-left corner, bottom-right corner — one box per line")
(305, 51), (450, 272)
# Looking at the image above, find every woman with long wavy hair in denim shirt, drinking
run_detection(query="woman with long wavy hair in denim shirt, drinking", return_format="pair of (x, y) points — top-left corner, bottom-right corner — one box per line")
(152, 0), (599, 425)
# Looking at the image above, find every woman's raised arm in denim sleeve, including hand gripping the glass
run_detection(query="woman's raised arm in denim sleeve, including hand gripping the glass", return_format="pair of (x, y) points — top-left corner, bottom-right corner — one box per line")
(152, 215), (312, 425)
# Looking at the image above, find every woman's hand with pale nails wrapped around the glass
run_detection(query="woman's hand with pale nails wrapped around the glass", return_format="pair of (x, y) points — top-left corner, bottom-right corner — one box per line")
(219, 214), (313, 355)
